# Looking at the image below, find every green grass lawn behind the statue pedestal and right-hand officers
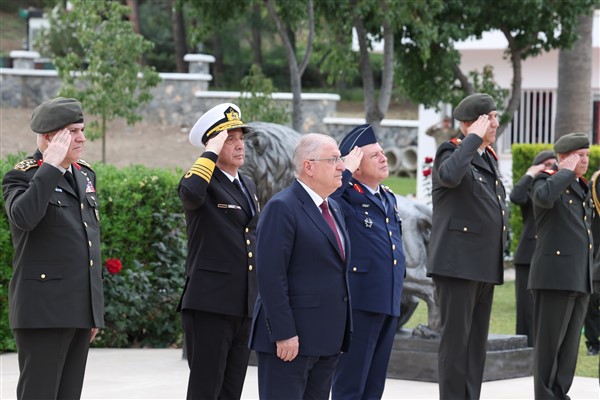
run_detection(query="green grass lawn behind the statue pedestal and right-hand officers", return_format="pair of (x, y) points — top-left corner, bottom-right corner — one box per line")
(404, 281), (598, 378)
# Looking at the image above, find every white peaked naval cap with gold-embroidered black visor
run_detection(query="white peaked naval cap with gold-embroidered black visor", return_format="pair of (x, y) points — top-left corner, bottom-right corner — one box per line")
(190, 103), (251, 147)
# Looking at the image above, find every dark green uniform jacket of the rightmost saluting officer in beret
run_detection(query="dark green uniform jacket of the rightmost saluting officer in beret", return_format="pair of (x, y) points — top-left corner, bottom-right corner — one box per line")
(528, 169), (593, 293)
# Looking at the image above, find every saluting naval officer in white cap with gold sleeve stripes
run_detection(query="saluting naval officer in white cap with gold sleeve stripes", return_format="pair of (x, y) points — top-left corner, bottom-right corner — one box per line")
(178, 103), (259, 399)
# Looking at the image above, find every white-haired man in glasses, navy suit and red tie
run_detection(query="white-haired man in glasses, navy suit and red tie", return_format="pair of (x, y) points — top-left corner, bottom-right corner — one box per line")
(250, 133), (352, 399)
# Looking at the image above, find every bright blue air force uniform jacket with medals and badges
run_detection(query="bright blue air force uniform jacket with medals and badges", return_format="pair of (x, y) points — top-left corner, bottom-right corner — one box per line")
(330, 170), (406, 317)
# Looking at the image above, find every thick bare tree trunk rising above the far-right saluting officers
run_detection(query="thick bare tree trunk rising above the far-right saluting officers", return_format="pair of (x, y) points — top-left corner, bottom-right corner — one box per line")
(554, 14), (593, 140)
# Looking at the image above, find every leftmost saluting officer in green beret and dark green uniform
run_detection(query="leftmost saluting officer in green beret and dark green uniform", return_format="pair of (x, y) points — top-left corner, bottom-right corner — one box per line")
(2, 97), (104, 399)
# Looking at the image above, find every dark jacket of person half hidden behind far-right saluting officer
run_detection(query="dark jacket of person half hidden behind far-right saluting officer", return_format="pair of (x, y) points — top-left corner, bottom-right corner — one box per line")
(510, 174), (536, 265)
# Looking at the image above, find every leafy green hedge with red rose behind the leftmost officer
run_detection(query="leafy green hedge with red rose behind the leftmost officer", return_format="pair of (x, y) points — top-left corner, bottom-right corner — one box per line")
(0, 155), (187, 351)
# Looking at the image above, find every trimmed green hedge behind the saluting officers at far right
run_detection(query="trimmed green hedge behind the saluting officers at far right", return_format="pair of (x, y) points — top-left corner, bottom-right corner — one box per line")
(510, 143), (600, 253)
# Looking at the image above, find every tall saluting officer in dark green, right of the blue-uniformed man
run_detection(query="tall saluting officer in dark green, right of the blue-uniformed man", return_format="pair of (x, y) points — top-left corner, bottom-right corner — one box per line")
(427, 93), (508, 399)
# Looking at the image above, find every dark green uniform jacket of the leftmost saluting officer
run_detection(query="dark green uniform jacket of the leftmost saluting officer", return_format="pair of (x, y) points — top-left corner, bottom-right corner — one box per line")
(2, 150), (104, 329)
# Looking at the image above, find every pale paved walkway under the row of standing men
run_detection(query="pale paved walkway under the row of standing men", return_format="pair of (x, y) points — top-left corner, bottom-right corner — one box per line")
(0, 349), (600, 400)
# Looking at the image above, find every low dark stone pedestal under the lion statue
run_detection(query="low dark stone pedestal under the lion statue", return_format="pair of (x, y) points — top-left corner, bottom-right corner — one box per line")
(387, 329), (533, 382)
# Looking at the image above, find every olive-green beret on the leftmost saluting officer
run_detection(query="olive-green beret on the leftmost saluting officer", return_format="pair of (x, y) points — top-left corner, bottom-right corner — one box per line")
(29, 97), (83, 133)
